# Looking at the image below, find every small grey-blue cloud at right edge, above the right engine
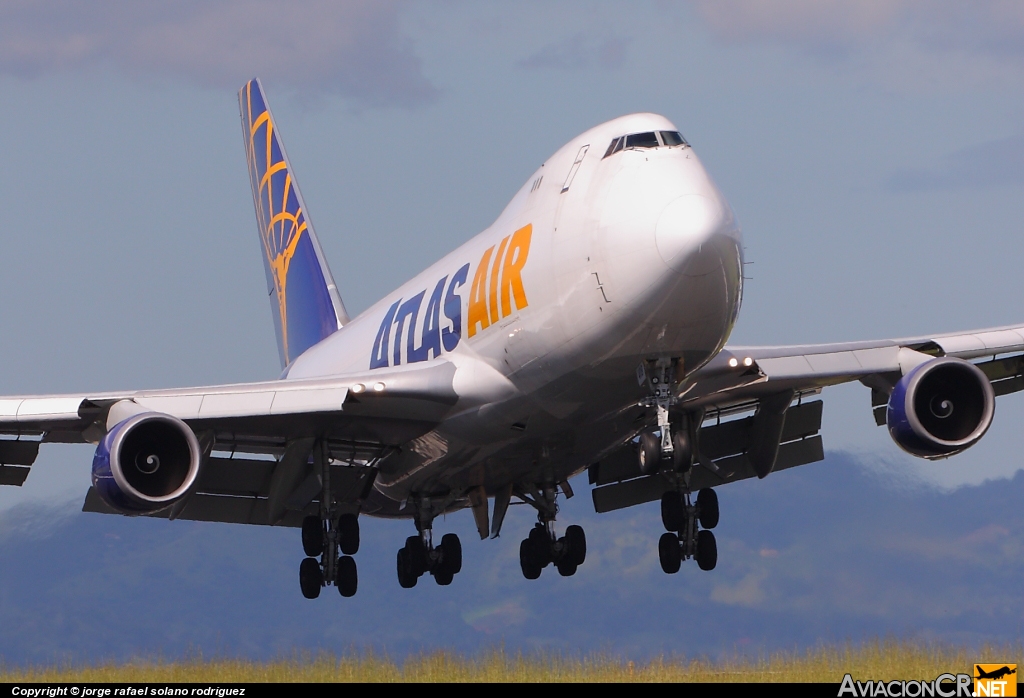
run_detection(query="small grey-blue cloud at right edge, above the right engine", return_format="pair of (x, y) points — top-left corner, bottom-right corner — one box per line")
(887, 135), (1024, 191)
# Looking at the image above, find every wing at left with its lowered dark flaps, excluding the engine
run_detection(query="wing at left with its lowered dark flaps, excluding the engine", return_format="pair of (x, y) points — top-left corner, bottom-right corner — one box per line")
(0, 361), (459, 526)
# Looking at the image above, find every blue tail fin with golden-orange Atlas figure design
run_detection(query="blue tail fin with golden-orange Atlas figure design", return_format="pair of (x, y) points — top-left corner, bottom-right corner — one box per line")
(239, 79), (348, 366)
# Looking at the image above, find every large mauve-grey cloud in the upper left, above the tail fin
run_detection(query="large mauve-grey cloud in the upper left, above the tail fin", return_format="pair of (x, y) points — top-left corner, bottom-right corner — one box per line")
(0, 0), (436, 106)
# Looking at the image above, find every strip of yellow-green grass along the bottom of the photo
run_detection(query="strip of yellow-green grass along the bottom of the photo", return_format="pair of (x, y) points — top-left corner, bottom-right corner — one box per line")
(0, 641), (1024, 683)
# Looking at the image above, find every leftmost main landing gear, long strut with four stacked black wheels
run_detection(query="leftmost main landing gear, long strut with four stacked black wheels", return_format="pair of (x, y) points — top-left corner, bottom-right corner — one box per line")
(299, 442), (359, 599)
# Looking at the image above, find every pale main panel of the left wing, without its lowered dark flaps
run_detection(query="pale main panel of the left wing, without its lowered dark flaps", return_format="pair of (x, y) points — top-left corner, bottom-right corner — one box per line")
(0, 361), (459, 440)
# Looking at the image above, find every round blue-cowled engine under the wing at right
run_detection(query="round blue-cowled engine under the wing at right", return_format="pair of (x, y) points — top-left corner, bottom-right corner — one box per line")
(886, 357), (995, 460)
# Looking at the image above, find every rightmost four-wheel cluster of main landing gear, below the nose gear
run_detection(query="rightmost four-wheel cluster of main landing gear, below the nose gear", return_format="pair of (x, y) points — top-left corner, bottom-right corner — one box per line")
(657, 487), (718, 574)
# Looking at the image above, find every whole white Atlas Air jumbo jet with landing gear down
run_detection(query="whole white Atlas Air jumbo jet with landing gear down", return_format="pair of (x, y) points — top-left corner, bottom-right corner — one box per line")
(0, 79), (1024, 599)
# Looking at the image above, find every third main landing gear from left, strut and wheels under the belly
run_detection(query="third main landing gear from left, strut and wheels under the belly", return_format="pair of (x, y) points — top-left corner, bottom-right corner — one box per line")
(519, 485), (587, 579)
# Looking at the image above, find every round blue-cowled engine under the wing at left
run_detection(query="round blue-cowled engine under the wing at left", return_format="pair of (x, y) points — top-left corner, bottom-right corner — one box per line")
(92, 412), (201, 514)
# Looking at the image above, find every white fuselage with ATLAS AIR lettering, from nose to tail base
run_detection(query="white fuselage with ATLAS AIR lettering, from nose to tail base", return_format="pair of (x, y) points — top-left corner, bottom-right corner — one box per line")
(288, 114), (742, 516)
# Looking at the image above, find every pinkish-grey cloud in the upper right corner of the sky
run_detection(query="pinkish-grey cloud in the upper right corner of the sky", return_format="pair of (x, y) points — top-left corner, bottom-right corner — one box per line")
(693, 0), (1024, 90)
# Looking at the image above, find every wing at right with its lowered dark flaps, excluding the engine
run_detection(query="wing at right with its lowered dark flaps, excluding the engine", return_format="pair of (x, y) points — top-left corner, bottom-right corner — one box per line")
(589, 325), (1024, 512)
